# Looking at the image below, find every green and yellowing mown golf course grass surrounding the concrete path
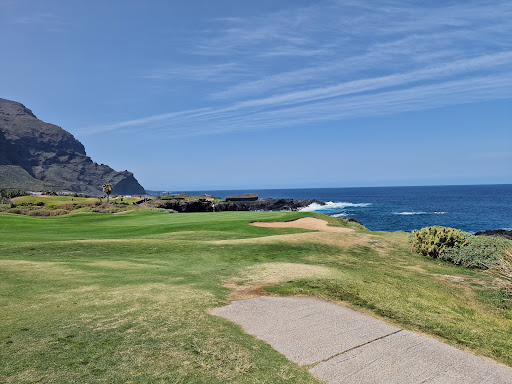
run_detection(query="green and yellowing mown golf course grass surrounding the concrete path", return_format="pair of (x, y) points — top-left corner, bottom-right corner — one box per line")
(0, 211), (512, 383)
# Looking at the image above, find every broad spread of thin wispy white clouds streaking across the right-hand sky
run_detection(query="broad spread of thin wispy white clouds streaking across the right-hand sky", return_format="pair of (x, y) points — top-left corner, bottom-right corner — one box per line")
(90, 0), (512, 136)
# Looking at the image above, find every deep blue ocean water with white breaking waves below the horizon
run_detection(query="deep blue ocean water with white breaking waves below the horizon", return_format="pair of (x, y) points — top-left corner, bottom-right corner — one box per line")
(158, 184), (512, 233)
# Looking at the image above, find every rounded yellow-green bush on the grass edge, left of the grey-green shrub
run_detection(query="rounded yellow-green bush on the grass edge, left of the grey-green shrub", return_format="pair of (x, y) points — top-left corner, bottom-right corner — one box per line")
(409, 226), (471, 259)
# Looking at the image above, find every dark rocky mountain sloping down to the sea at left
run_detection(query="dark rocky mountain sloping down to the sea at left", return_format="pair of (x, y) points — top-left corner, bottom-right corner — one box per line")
(0, 98), (145, 195)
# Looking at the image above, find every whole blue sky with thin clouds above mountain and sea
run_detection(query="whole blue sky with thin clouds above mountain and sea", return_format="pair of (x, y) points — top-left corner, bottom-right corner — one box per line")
(0, 0), (512, 190)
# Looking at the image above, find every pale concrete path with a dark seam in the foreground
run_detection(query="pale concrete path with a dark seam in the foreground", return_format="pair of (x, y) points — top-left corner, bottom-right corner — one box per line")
(212, 297), (512, 384)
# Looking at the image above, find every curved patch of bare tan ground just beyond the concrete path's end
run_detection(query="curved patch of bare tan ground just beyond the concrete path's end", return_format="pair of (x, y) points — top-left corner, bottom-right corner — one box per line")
(224, 263), (333, 300)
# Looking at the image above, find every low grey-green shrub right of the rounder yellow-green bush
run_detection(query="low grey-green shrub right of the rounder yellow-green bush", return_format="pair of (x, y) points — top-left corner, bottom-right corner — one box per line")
(440, 235), (512, 269)
